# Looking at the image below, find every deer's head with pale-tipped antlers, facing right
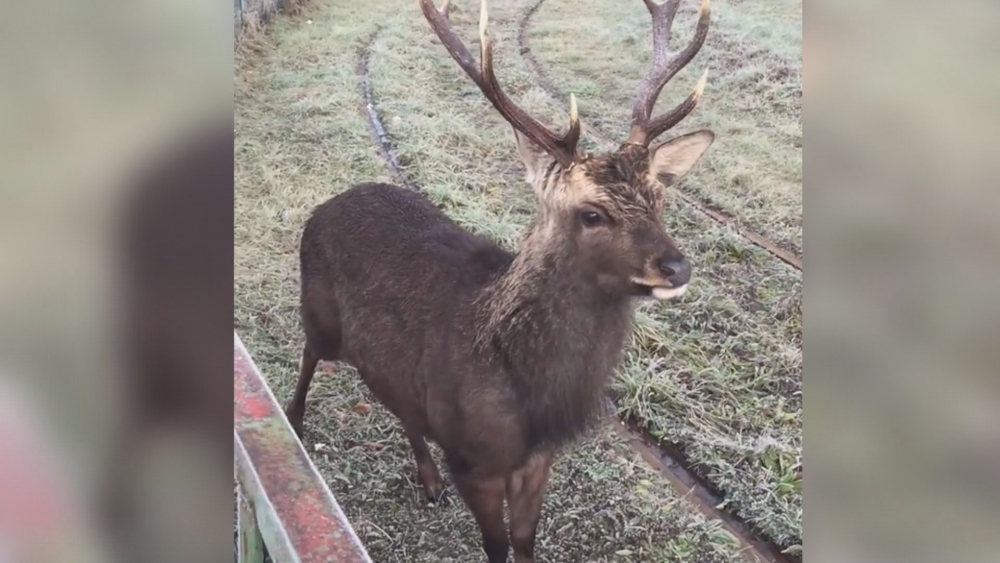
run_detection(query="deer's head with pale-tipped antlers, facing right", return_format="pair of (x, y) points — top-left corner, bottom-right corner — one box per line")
(420, 0), (714, 299)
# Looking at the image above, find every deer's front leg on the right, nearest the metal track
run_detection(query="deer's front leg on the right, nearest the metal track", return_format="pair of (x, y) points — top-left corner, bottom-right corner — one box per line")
(507, 452), (553, 563)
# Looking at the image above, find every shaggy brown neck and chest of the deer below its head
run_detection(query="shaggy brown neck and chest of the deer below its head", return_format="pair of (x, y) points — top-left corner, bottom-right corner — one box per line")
(477, 220), (633, 443)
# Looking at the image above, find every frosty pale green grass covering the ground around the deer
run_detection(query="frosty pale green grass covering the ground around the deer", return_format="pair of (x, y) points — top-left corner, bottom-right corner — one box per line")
(234, 0), (802, 562)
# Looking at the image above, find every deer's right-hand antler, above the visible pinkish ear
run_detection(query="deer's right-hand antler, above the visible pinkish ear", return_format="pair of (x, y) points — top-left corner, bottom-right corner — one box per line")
(626, 0), (711, 146)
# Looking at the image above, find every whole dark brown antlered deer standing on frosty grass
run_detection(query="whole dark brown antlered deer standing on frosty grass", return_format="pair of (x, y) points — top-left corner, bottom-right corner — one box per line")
(285, 0), (714, 563)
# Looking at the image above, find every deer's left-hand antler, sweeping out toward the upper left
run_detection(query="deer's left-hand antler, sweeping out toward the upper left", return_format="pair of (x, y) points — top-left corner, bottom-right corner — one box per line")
(420, 0), (580, 167)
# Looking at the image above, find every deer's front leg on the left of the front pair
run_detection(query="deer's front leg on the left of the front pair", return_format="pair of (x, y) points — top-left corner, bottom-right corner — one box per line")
(455, 474), (510, 563)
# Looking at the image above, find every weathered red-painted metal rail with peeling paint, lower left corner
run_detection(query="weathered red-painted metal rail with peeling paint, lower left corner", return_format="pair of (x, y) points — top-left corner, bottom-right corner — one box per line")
(233, 334), (371, 563)
